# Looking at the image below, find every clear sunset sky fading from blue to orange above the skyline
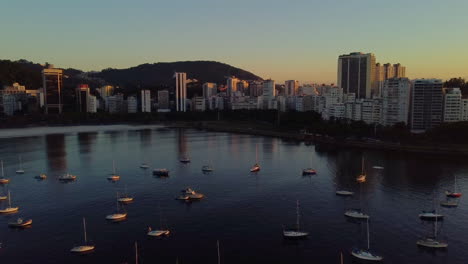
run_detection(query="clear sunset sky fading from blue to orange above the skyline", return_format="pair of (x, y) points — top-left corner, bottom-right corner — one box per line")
(0, 0), (468, 83)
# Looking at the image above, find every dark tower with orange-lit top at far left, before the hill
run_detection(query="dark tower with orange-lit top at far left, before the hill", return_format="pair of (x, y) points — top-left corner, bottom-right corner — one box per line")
(42, 67), (63, 114)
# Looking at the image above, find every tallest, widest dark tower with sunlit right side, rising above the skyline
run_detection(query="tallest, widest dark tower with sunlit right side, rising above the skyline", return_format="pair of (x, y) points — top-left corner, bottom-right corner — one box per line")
(338, 52), (376, 98)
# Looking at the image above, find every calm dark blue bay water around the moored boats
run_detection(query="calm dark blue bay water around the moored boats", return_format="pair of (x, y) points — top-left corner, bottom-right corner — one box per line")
(0, 126), (468, 264)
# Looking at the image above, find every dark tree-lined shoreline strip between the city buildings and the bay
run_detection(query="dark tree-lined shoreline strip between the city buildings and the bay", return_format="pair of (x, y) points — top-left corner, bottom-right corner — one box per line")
(0, 121), (468, 156)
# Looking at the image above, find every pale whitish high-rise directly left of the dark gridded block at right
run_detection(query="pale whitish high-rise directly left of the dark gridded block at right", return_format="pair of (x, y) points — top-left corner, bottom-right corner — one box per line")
(381, 78), (411, 126)
